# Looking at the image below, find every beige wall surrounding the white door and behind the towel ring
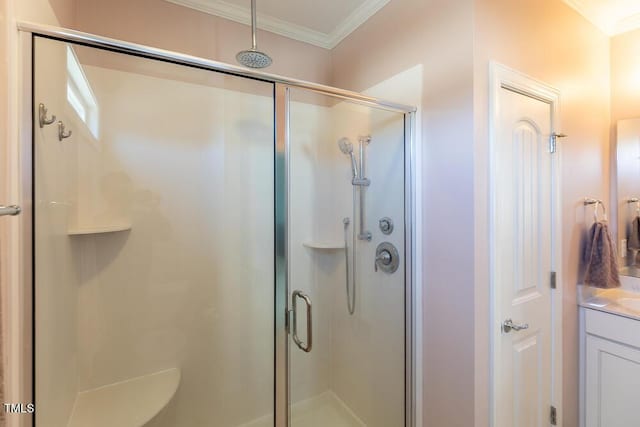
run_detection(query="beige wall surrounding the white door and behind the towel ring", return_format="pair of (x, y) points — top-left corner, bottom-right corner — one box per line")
(474, 0), (609, 427)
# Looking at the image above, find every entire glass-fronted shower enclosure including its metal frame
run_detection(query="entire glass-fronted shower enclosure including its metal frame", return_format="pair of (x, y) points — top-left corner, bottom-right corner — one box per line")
(18, 24), (415, 427)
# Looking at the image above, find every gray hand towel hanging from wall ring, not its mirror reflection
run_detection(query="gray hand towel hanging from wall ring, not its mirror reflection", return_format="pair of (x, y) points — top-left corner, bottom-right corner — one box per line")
(584, 221), (620, 288)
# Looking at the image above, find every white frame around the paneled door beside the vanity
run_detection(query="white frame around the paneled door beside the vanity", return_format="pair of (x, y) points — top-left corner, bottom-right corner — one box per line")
(489, 61), (564, 427)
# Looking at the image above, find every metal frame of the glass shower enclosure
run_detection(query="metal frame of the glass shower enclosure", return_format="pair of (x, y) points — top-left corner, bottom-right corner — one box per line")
(13, 22), (421, 427)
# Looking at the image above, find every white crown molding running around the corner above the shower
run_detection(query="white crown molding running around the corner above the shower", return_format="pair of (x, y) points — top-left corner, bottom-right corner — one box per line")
(165, 0), (391, 49)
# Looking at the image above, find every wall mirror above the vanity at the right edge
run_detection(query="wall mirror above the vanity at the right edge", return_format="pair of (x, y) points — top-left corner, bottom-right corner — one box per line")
(616, 118), (640, 277)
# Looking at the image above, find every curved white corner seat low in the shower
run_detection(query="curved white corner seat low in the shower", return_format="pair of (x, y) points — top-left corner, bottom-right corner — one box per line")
(68, 368), (180, 427)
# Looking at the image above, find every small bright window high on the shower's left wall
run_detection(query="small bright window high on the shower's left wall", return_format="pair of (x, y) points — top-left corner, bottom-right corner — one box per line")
(67, 46), (99, 139)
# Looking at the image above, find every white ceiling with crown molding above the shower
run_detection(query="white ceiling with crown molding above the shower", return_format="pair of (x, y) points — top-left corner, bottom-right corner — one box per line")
(166, 0), (391, 49)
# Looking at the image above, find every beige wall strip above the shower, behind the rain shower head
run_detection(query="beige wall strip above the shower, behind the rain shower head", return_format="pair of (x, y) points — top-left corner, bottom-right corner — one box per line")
(73, 0), (331, 84)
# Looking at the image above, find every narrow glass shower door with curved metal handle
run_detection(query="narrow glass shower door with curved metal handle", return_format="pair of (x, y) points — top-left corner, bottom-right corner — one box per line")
(287, 88), (409, 427)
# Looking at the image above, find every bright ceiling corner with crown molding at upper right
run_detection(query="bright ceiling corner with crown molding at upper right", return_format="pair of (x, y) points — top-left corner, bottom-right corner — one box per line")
(562, 0), (640, 36)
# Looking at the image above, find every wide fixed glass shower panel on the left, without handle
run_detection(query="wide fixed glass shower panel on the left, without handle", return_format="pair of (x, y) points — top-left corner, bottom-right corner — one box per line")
(33, 37), (275, 427)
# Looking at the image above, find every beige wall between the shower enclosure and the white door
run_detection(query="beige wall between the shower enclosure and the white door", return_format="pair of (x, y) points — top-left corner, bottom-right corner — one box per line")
(332, 0), (474, 427)
